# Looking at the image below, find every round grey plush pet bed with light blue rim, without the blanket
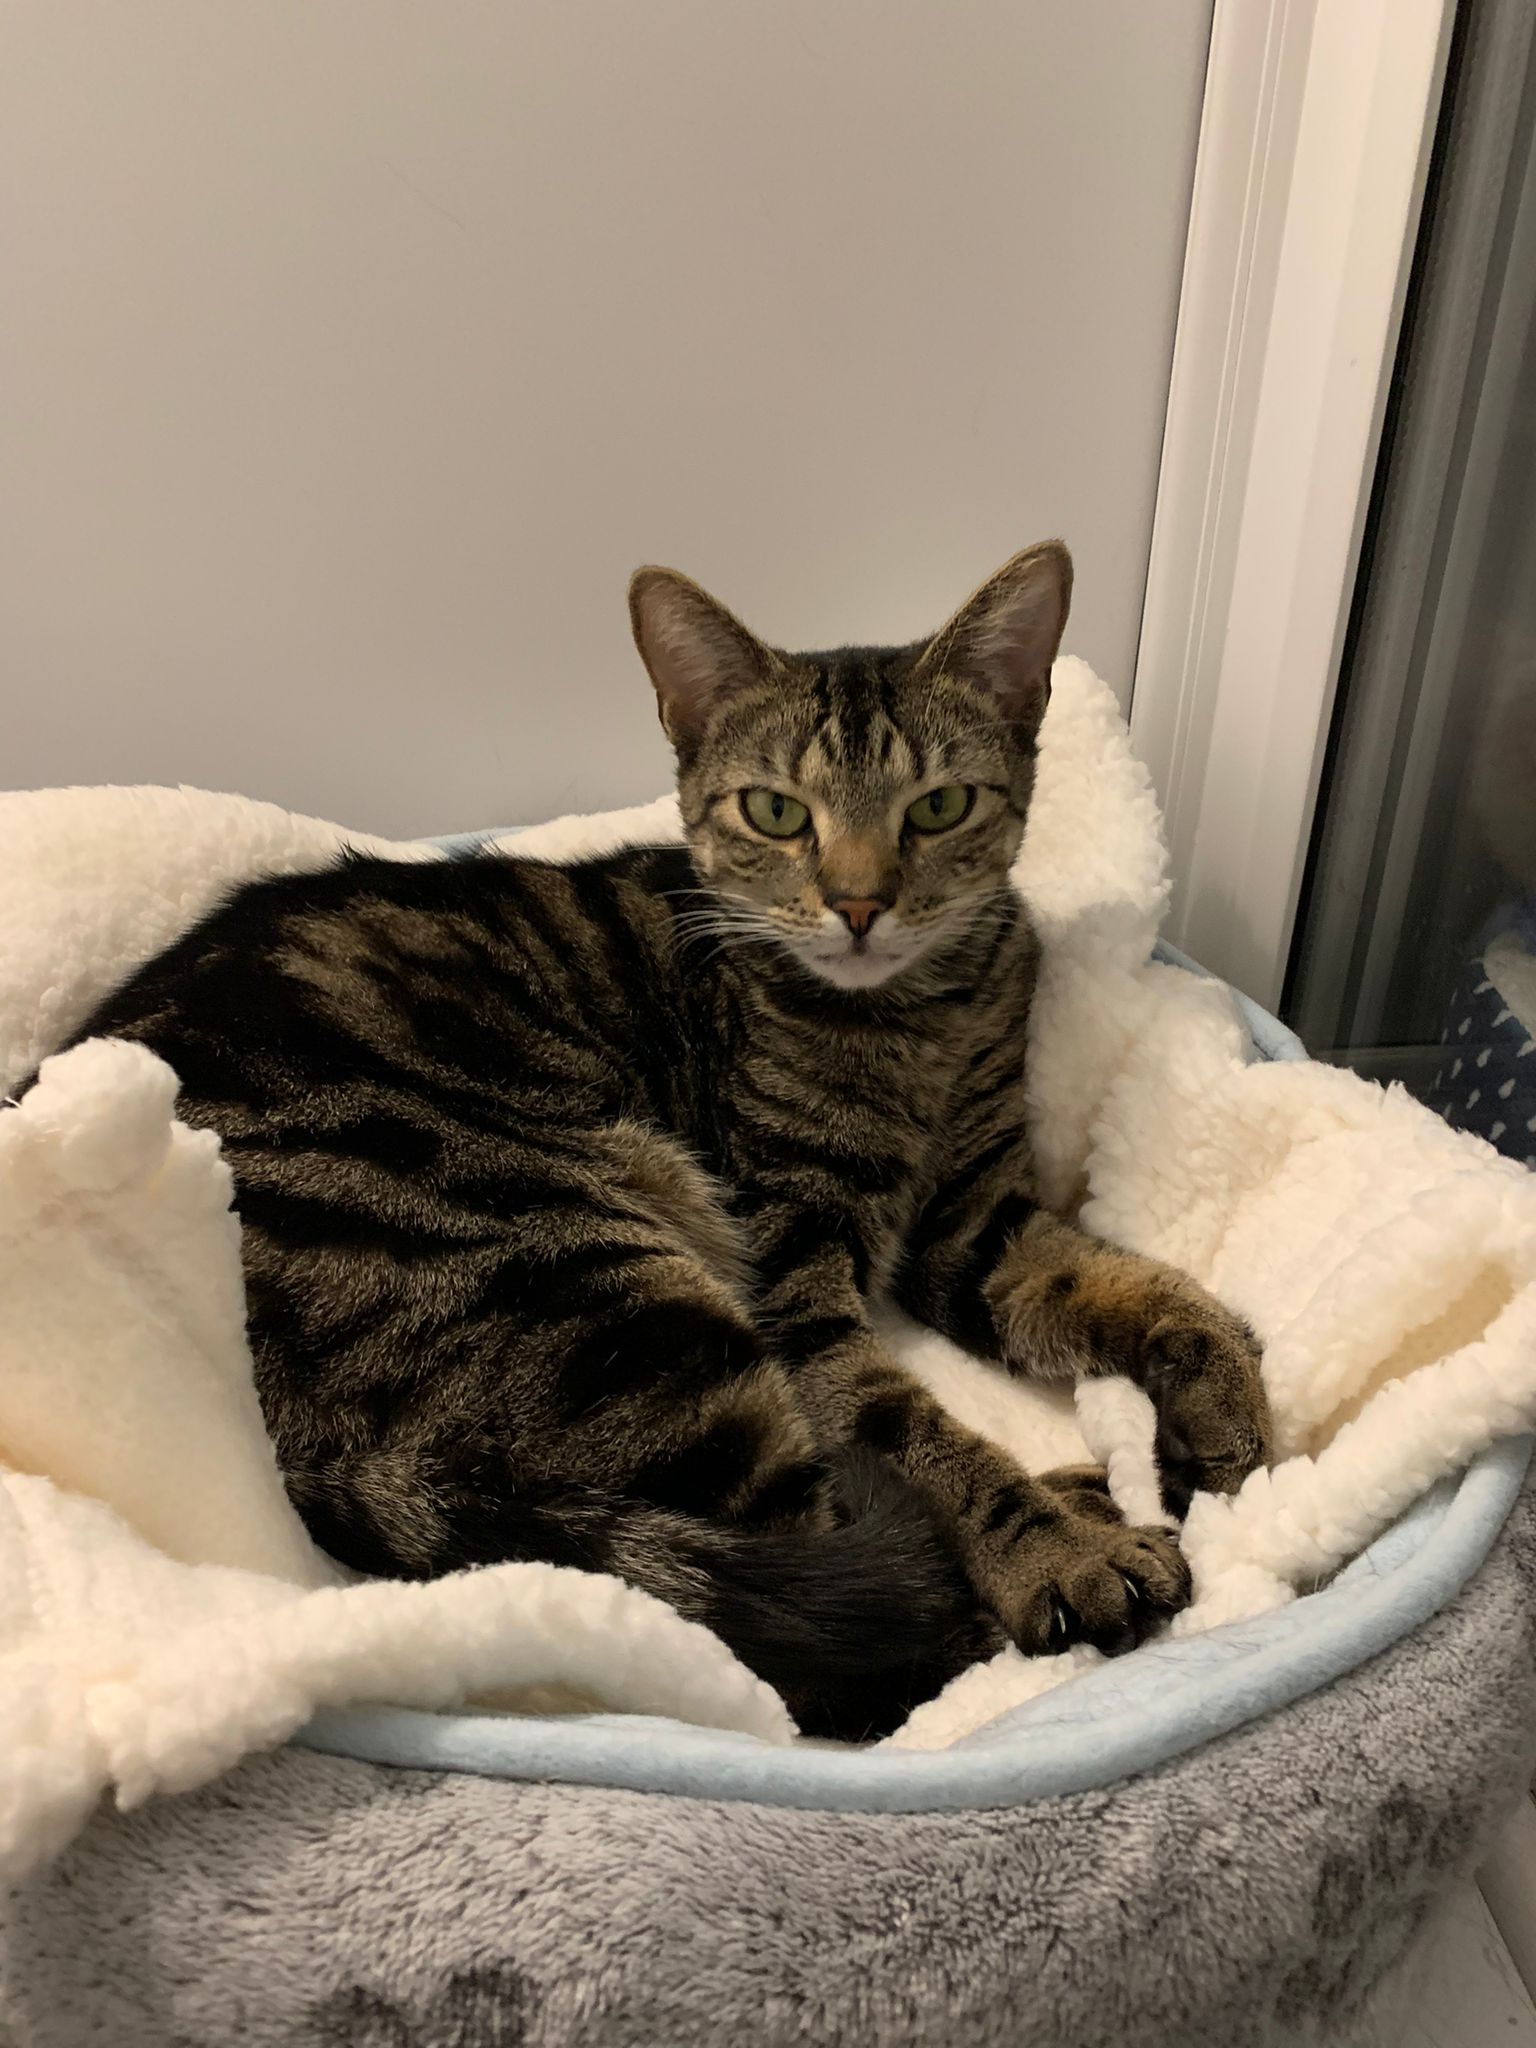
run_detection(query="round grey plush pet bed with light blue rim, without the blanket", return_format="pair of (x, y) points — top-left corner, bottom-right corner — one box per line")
(0, 963), (1536, 2048)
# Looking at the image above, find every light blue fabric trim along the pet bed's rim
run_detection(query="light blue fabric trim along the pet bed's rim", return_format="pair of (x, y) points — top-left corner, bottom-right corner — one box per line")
(295, 834), (1532, 1812)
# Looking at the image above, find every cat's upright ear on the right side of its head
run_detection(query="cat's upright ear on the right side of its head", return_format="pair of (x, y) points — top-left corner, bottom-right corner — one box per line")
(918, 541), (1071, 737)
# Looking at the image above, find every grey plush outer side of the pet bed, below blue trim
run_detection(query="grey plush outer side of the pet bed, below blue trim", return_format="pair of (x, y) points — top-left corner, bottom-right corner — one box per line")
(0, 1495), (1536, 2048)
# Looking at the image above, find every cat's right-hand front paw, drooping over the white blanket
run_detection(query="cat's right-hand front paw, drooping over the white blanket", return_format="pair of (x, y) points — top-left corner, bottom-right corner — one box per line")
(1141, 1288), (1274, 1520)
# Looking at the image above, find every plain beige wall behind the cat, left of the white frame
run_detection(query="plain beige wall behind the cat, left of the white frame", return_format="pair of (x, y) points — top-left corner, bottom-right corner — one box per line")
(0, 0), (1210, 831)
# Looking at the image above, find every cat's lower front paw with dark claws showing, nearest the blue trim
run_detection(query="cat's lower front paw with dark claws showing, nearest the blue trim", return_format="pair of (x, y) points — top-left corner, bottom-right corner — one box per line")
(977, 1511), (1190, 1657)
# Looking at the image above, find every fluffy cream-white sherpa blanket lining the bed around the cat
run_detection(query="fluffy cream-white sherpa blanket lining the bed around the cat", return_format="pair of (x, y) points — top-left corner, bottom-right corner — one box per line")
(0, 662), (1536, 1872)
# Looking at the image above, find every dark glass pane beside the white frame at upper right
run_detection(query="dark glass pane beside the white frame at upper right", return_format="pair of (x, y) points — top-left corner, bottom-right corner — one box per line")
(1284, 4), (1536, 1163)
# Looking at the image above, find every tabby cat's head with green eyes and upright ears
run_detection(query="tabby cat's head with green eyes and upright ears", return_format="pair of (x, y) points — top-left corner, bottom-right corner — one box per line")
(629, 541), (1071, 987)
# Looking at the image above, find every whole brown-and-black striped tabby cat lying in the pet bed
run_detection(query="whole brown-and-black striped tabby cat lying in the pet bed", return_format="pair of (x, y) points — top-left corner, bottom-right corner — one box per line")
(54, 543), (1268, 1737)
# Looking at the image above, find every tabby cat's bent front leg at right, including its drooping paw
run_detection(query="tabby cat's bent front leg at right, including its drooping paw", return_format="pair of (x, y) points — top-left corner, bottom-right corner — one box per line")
(897, 1137), (1272, 1513)
